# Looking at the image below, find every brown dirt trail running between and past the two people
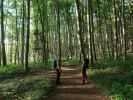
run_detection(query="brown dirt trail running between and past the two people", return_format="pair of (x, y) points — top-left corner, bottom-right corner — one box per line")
(46, 66), (106, 100)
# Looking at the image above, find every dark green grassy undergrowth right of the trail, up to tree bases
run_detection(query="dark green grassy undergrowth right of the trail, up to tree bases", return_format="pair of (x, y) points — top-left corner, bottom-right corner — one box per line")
(89, 55), (133, 100)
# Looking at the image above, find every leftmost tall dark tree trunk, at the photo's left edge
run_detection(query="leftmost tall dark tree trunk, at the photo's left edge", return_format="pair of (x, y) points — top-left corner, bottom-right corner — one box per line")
(1, 0), (6, 66)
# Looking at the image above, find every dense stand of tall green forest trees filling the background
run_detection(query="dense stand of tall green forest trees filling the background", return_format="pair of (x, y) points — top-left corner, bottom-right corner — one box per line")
(0, 0), (133, 69)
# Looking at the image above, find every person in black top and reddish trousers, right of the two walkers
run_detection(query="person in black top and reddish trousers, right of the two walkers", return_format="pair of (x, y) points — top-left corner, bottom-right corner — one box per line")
(82, 58), (89, 84)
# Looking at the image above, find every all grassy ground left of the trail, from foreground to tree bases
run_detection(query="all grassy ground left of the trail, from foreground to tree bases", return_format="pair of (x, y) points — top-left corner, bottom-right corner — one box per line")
(0, 62), (54, 100)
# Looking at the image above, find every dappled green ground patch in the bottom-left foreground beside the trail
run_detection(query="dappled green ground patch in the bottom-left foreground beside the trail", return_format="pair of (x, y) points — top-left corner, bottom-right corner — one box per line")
(0, 76), (52, 100)
